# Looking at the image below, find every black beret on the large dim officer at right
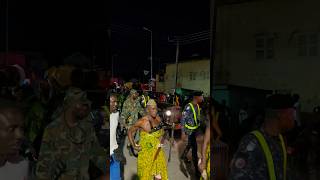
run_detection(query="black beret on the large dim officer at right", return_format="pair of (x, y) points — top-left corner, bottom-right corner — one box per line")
(266, 94), (294, 110)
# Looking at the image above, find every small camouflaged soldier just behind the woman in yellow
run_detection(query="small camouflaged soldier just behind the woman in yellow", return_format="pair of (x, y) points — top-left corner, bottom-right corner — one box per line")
(120, 89), (145, 155)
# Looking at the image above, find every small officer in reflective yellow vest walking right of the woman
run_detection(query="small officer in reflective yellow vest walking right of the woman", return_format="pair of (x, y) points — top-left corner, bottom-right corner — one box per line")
(181, 92), (203, 178)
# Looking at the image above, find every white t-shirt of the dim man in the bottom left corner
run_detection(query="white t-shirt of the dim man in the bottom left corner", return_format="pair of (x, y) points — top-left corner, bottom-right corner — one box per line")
(0, 160), (29, 180)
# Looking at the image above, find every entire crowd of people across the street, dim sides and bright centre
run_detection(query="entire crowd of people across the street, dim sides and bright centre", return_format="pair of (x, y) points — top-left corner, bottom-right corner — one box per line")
(0, 62), (320, 180)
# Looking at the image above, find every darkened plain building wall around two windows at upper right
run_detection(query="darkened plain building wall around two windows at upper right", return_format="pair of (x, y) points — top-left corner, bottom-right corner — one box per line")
(215, 0), (320, 111)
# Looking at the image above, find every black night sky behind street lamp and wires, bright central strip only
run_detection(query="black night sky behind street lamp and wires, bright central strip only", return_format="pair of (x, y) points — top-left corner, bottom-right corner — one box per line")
(111, 0), (210, 79)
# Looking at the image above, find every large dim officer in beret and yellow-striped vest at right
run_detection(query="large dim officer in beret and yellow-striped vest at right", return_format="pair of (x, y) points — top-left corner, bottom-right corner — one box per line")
(229, 94), (294, 180)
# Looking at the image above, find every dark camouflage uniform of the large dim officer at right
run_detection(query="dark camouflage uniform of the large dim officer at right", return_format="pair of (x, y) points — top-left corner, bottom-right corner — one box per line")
(229, 130), (284, 180)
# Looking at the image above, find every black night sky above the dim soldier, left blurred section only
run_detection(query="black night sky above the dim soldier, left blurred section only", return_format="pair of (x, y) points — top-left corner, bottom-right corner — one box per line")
(0, 0), (110, 66)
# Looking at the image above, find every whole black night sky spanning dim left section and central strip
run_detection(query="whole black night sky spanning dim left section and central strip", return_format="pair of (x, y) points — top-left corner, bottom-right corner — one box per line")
(0, 0), (210, 76)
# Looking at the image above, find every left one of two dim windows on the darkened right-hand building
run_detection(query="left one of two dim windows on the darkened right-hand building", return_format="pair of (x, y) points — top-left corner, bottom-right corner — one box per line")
(256, 35), (274, 60)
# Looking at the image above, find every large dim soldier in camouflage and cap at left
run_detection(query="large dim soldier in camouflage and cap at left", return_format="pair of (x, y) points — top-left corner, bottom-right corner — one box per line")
(36, 88), (107, 180)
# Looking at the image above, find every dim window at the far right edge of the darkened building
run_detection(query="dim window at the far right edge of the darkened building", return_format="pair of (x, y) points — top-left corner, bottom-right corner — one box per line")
(297, 33), (318, 57)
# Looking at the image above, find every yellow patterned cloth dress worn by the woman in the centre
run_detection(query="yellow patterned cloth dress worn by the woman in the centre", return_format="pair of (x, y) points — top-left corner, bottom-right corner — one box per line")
(138, 129), (168, 180)
